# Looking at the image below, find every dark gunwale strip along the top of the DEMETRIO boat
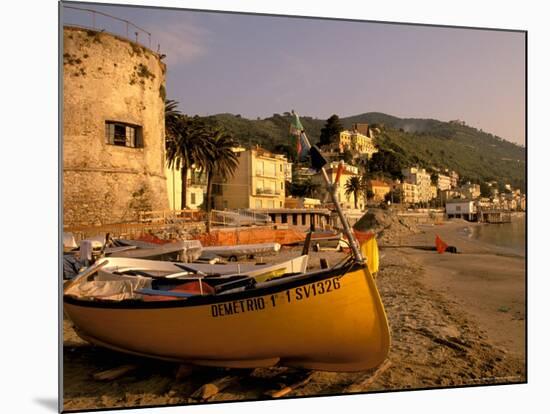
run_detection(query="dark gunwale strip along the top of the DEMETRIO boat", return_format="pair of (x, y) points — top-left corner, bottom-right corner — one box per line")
(63, 262), (362, 310)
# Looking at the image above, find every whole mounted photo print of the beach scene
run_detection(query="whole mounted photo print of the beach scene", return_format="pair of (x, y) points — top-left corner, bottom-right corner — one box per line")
(59, 2), (527, 412)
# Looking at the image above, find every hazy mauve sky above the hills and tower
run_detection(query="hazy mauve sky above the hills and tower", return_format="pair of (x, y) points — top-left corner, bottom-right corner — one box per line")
(63, 3), (525, 145)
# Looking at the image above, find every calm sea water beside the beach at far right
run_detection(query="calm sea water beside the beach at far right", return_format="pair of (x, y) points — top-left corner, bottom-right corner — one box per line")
(472, 214), (526, 256)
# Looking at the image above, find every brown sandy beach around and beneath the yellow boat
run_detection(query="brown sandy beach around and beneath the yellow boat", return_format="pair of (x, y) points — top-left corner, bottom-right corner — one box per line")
(63, 221), (526, 410)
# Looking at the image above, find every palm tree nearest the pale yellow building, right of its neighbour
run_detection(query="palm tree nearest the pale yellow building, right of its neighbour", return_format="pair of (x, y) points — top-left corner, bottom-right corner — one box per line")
(204, 127), (239, 232)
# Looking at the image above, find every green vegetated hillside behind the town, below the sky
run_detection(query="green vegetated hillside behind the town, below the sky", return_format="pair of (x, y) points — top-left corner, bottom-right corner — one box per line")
(203, 112), (526, 191)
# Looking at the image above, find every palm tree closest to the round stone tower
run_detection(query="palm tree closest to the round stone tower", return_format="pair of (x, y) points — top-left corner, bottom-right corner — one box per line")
(166, 114), (211, 209)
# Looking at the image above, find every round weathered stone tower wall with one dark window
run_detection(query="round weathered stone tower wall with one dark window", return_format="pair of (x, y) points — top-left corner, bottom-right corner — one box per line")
(63, 27), (168, 226)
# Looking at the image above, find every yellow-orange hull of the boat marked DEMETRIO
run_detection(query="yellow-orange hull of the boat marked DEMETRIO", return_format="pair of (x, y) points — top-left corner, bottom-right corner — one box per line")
(64, 266), (390, 371)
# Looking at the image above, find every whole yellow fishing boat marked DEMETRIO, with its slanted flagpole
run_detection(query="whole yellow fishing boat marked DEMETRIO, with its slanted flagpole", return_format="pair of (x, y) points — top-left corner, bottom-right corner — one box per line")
(63, 114), (390, 371)
